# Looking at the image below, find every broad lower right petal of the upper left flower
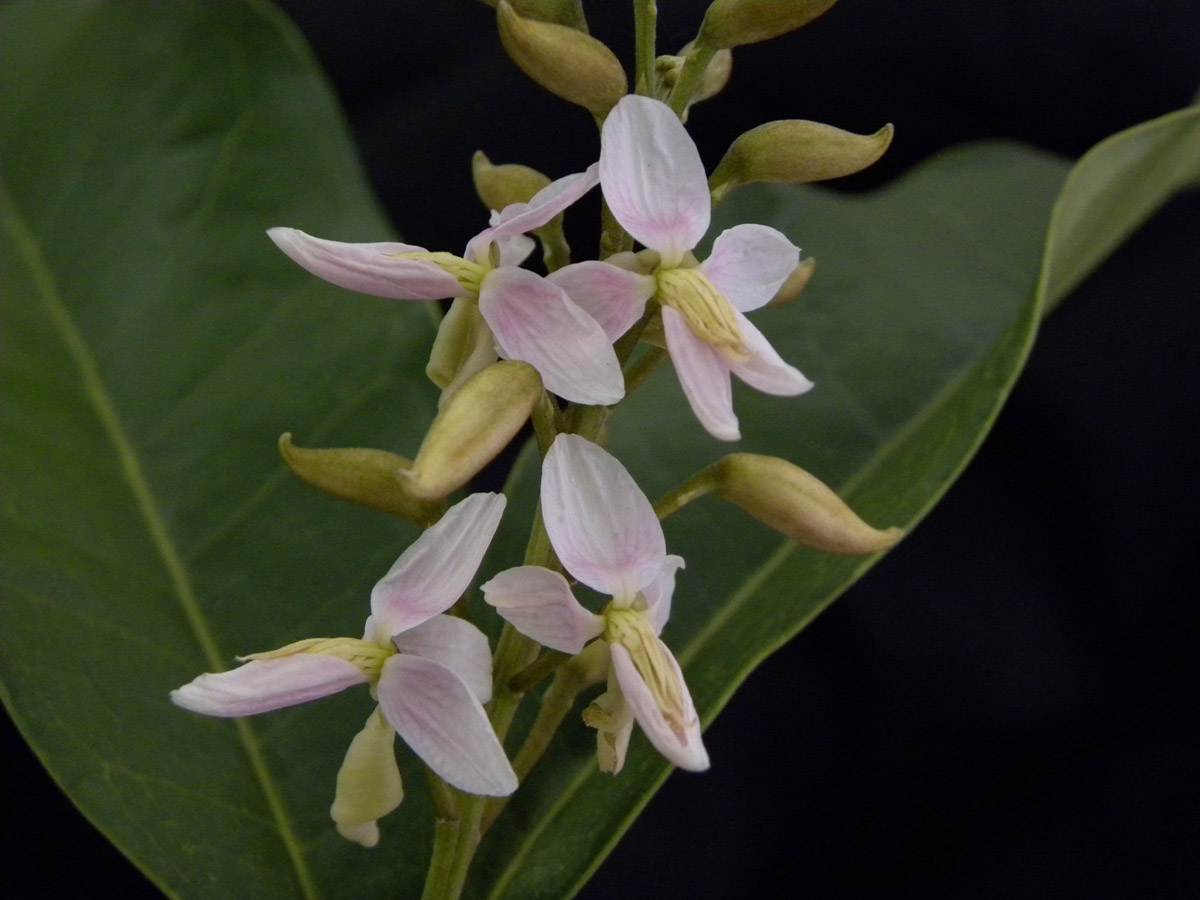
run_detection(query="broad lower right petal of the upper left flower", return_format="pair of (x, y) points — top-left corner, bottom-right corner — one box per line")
(479, 268), (625, 406)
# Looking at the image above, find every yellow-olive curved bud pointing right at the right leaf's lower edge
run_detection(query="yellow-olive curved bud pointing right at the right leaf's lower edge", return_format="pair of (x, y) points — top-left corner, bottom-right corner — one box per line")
(712, 454), (904, 556)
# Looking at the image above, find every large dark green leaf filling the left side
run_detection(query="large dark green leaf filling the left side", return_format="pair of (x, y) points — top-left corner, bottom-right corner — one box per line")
(0, 0), (446, 900)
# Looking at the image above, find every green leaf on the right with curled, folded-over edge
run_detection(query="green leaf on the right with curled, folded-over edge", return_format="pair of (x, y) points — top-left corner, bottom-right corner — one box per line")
(468, 107), (1200, 900)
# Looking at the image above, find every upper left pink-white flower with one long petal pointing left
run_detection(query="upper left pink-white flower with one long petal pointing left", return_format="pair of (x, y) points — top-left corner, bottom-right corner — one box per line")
(268, 164), (625, 406)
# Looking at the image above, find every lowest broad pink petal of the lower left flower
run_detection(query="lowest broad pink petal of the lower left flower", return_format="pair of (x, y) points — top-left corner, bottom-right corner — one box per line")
(378, 653), (517, 797)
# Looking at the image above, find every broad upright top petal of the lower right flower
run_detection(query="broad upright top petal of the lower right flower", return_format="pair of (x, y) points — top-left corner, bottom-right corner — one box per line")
(541, 434), (667, 602)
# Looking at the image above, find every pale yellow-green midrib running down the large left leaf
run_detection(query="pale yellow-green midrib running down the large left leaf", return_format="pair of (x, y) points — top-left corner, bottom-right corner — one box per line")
(0, 179), (319, 900)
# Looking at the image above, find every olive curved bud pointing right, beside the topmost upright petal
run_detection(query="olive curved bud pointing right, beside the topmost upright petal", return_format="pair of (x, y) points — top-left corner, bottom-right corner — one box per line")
(708, 119), (894, 203)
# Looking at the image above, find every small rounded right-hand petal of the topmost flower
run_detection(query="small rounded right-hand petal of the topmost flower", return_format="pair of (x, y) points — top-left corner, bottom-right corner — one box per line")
(700, 224), (800, 312)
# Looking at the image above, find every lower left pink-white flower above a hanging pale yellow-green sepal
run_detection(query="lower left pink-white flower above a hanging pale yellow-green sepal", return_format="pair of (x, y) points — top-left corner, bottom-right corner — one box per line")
(170, 493), (517, 847)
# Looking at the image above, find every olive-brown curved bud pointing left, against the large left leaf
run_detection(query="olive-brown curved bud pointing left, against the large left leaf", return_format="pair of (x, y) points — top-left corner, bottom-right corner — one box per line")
(280, 432), (445, 528)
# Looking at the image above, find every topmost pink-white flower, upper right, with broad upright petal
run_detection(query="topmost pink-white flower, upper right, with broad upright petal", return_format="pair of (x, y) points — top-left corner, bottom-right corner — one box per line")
(564, 95), (812, 440)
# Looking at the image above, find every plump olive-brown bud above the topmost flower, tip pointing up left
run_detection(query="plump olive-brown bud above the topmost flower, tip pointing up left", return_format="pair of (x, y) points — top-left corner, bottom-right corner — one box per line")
(496, 0), (628, 118)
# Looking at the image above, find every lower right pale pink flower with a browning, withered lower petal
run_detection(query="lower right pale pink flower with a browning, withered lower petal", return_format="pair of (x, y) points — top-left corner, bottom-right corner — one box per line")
(482, 434), (708, 773)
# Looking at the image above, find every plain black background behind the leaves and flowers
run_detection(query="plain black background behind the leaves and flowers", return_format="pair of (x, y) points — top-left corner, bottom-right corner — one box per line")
(0, 0), (1200, 900)
